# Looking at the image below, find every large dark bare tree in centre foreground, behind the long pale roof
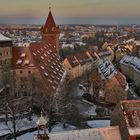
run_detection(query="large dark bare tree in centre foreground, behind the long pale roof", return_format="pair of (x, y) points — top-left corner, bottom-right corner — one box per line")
(35, 85), (83, 132)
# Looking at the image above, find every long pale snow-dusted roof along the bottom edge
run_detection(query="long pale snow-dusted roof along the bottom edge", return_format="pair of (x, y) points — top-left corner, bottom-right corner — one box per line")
(50, 126), (121, 140)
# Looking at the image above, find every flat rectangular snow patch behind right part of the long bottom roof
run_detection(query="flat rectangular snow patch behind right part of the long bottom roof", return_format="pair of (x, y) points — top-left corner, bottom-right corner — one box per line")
(87, 120), (110, 128)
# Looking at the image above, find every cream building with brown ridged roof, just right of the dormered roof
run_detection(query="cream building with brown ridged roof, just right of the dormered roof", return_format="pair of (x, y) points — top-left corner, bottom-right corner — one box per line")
(63, 51), (99, 80)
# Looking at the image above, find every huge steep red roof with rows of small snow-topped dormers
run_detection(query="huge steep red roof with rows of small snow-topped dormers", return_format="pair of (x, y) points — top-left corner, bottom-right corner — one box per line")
(29, 38), (65, 91)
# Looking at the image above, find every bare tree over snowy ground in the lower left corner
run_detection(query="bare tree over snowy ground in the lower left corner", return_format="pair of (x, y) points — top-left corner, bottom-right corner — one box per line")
(3, 98), (30, 140)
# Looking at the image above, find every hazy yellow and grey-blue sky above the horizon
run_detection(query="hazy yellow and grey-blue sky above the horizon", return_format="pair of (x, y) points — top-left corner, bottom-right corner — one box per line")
(0, 0), (140, 25)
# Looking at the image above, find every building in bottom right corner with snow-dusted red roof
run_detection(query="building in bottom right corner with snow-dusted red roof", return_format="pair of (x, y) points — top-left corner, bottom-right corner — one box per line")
(111, 100), (140, 140)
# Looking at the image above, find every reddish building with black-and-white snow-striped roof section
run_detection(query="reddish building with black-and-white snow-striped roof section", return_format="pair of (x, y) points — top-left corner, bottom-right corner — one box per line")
(97, 59), (128, 105)
